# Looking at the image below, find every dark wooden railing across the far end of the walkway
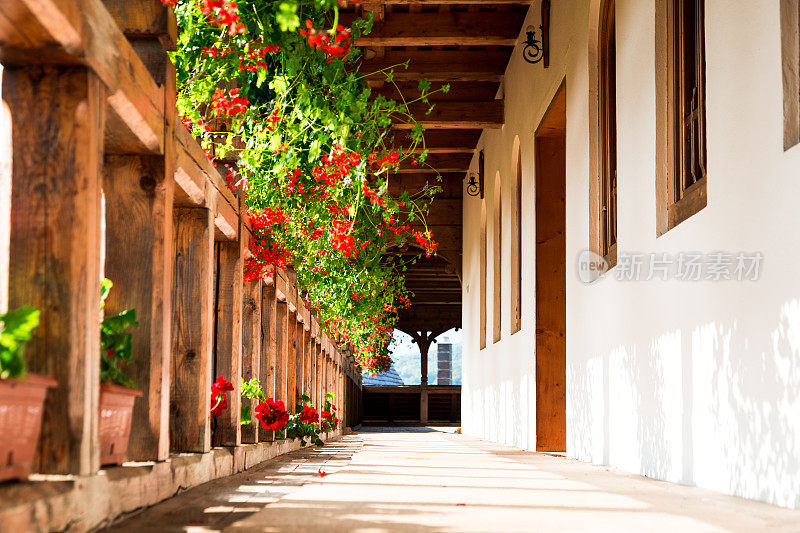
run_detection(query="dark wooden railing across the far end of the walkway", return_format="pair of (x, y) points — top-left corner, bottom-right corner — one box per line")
(363, 385), (461, 426)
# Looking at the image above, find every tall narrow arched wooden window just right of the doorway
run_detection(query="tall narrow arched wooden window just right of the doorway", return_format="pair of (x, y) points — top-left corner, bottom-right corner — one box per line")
(589, 0), (619, 268)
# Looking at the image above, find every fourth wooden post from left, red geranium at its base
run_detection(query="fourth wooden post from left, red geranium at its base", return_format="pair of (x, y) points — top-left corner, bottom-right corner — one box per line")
(214, 231), (242, 446)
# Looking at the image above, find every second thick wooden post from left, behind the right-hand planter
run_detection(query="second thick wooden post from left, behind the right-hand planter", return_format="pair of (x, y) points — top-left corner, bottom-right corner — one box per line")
(103, 0), (177, 461)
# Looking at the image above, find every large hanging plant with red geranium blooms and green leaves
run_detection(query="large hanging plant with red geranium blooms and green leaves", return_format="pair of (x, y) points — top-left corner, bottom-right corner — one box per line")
(164, 0), (447, 372)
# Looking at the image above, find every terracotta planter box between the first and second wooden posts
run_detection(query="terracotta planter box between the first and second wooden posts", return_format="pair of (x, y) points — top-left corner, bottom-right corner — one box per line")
(97, 383), (142, 465)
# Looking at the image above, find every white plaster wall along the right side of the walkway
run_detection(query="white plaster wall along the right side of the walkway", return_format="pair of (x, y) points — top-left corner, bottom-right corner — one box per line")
(463, 0), (800, 508)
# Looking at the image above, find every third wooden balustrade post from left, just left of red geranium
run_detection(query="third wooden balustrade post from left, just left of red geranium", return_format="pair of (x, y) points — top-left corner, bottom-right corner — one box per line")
(169, 208), (214, 452)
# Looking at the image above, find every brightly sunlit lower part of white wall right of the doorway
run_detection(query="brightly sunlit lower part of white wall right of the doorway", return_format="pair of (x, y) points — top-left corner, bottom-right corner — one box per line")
(567, 299), (800, 508)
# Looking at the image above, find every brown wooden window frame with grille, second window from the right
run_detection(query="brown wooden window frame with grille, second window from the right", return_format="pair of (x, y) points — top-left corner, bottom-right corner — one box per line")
(656, 0), (708, 235)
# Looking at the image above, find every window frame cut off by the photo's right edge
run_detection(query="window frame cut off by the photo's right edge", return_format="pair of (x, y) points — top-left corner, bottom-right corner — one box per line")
(780, 0), (800, 150)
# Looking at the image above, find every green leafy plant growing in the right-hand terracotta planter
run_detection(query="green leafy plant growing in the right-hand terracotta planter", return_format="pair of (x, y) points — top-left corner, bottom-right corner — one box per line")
(100, 279), (139, 389)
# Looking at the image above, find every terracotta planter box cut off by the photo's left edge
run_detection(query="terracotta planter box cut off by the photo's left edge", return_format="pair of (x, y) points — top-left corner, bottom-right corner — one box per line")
(0, 374), (58, 481)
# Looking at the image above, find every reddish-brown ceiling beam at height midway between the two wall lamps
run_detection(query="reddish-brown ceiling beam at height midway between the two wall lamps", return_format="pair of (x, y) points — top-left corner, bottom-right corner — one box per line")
(394, 100), (505, 129)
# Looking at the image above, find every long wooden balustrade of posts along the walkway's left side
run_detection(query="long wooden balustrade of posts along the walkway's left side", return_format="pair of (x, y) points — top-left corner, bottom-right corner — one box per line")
(0, 0), (361, 475)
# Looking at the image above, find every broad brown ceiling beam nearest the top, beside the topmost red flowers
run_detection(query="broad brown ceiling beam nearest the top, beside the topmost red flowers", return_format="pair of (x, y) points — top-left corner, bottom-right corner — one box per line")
(340, 11), (525, 47)
